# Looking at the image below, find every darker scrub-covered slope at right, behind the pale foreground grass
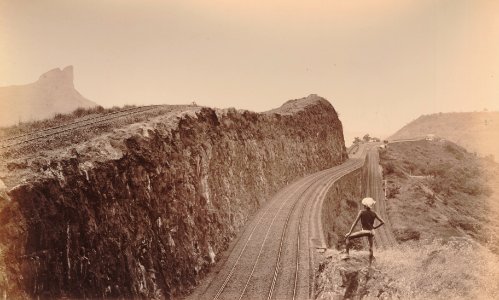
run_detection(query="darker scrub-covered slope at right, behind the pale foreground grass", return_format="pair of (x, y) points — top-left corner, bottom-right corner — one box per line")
(381, 141), (499, 248)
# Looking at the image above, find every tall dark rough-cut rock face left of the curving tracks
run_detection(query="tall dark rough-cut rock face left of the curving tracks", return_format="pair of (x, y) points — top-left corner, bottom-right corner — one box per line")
(0, 96), (347, 298)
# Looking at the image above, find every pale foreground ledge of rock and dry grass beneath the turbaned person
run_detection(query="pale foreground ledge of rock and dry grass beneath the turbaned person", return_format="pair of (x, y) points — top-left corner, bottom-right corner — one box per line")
(316, 239), (499, 300)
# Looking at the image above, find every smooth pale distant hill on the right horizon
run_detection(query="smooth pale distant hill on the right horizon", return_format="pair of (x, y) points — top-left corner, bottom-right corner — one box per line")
(388, 112), (499, 161)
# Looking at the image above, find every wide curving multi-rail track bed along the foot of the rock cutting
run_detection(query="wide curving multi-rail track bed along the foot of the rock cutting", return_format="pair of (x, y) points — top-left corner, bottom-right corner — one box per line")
(188, 149), (374, 299)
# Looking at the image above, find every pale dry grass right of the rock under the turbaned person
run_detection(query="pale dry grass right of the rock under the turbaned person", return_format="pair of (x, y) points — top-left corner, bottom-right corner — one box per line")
(376, 239), (499, 299)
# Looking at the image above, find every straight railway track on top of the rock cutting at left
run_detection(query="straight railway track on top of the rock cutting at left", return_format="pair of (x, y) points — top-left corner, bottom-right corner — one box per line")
(0, 105), (170, 149)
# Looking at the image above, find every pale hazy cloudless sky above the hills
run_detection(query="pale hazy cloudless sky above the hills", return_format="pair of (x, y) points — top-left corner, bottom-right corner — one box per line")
(0, 0), (499, 143)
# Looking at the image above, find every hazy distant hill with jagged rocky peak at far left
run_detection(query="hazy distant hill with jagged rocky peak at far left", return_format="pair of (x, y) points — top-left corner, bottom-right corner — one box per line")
(0, 66), (97, 126)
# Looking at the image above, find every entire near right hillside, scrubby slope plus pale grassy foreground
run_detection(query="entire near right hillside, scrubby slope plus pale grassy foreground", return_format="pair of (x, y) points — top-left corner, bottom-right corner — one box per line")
(316, 140), (499, 299)
